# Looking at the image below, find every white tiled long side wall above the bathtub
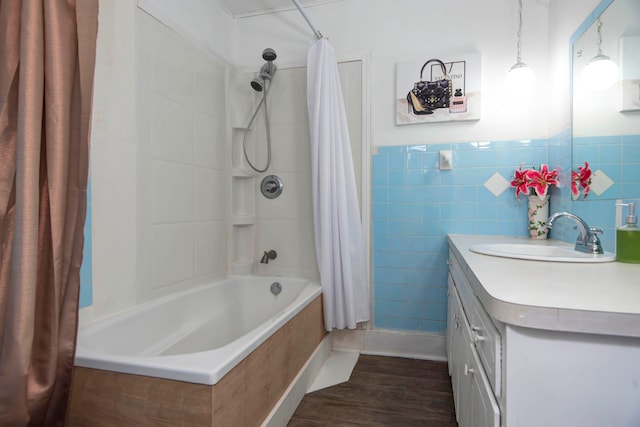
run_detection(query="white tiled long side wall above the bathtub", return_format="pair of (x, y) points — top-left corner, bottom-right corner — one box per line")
(136, 9), (228, 302)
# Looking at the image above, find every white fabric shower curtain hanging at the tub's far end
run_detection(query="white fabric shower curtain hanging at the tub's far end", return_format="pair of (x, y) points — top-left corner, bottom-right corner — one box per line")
(307, 38), (369, 331)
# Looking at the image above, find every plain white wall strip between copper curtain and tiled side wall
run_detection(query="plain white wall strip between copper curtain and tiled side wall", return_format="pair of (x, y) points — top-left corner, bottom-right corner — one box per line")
(90, 2), (137, 317)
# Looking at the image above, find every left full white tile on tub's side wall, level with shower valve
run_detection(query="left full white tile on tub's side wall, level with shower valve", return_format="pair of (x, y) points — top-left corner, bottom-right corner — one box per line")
(152, 160), (194, 224)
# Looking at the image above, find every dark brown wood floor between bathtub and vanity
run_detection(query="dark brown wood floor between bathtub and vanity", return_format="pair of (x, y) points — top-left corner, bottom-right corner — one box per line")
(288, 355), (458, 427)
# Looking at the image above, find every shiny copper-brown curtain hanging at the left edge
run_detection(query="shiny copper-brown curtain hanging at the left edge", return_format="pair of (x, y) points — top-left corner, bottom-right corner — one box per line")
(0, 0), (98, 426)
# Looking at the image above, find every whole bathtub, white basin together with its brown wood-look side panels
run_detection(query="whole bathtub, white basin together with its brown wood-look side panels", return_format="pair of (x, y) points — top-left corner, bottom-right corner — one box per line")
(66, 276), (328, 427)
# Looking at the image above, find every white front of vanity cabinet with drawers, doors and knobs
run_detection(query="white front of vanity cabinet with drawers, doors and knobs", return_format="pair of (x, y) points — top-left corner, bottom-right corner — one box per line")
(447, 254), (500, 427)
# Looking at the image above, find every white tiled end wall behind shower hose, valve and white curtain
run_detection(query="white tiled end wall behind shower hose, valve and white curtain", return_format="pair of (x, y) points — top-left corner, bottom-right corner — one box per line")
(248, 61), (362, 278)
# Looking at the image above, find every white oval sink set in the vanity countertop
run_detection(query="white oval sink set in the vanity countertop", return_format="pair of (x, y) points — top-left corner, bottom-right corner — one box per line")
(469, 240), (616, 262)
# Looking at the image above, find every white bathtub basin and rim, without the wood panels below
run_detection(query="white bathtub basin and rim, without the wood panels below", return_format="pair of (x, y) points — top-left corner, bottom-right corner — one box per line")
(75, 276), (321, 385)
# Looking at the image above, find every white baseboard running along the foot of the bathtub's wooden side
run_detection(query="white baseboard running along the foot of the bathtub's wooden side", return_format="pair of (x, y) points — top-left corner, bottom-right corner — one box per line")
(262, 335), (331, 427)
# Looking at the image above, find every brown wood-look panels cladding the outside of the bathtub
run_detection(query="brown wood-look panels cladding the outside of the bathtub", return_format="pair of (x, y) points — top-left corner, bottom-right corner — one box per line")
(67, 295), (326, 427)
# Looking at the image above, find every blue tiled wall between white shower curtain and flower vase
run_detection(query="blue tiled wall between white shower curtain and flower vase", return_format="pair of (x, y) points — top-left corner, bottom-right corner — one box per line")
(372, 135), (570, 334)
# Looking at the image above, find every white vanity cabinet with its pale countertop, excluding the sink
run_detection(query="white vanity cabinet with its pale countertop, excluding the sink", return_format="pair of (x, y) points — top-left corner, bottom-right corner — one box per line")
(447, 235), (640, 427)
